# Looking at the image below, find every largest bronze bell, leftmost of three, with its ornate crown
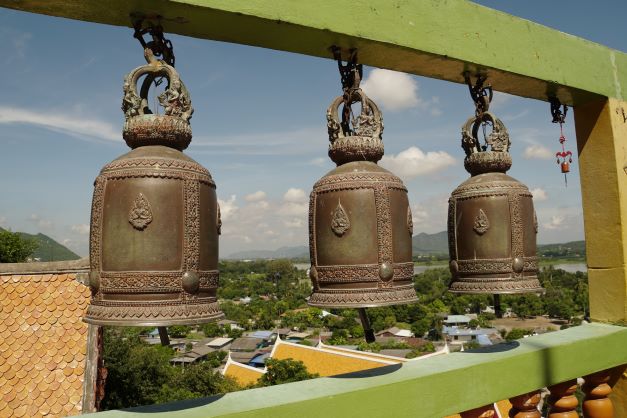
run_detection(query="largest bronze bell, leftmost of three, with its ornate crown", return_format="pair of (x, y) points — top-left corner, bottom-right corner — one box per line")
(85, 49), (223, 326)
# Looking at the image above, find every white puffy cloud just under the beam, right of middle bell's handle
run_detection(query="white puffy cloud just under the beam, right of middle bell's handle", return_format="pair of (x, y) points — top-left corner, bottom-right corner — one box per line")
(361, 68), (420, 110)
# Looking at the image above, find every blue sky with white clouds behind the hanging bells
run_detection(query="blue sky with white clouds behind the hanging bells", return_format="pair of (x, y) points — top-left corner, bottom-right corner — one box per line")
(0, 0), (627, 256)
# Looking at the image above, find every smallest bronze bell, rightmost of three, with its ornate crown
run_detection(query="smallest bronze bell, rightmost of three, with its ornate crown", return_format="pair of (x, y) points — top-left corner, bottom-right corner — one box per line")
(448, 112), (543, 294)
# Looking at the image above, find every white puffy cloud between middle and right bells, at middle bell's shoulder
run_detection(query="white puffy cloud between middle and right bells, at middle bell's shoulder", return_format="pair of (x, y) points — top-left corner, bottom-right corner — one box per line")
(380, 147), (455, 179)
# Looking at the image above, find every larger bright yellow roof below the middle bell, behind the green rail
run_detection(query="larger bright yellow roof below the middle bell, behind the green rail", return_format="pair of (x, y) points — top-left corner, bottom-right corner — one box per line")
(271, 338), (398, 377)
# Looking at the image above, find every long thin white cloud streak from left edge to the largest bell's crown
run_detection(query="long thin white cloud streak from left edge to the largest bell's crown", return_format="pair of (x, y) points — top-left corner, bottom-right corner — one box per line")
(0, 106), (122, 141)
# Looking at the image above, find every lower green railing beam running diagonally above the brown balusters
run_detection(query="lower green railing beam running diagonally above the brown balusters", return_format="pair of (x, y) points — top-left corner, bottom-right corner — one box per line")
(88, 324), (627, 418)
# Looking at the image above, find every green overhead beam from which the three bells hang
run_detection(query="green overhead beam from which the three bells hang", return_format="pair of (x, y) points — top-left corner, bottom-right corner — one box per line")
(0, 0), (627, 105)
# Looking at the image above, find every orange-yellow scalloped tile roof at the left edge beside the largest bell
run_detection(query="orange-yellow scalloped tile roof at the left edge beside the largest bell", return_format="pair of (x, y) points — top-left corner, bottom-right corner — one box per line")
(0, 274), (90, 417)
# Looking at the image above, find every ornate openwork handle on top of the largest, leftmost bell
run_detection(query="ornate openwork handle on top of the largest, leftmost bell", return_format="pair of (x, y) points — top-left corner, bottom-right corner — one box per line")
(122, 55), (194, 122)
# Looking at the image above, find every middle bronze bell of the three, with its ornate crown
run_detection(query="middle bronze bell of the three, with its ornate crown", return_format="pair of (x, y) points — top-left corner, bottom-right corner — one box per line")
(308, 88), (417, 310)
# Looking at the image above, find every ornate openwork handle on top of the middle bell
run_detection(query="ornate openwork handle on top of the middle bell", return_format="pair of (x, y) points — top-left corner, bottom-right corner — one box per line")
(327, 89), (383, 142)
